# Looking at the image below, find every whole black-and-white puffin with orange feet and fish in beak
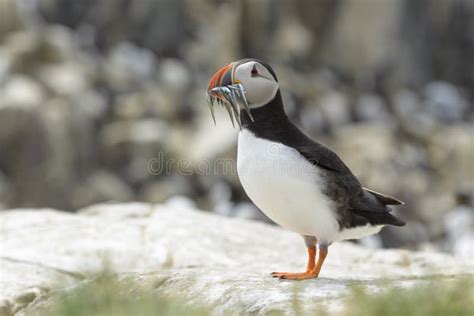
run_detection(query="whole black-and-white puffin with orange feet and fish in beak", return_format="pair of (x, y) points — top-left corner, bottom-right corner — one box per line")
(206, 58), (405, 280)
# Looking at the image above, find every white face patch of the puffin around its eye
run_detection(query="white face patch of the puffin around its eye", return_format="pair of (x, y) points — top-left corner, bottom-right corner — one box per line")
(233, 61), (279, 108)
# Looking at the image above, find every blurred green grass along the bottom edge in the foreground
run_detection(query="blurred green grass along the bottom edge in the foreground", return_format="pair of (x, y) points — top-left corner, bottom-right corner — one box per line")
(27, 273), (474, 316)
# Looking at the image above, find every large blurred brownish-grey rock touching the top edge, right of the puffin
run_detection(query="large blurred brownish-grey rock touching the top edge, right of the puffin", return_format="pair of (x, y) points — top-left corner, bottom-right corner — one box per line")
(322, 0), (404, 77)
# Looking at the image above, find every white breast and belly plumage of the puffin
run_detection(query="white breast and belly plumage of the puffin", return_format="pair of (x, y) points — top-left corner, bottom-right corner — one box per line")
(237, 130), (340, 242)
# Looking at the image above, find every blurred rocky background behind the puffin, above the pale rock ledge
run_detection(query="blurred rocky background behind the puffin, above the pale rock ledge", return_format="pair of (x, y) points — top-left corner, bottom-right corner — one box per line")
(0, 0), (474, 258)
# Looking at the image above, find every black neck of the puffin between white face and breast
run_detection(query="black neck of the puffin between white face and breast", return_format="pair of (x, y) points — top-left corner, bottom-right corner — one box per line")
(240, 90), (294, 138)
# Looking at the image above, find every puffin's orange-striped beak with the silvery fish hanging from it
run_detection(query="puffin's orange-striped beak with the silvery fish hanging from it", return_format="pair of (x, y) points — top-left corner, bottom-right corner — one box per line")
(207, 63), (253, 127)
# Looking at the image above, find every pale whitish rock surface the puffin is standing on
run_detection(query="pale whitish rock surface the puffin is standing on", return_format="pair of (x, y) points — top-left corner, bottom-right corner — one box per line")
(0, 203), (474, 314)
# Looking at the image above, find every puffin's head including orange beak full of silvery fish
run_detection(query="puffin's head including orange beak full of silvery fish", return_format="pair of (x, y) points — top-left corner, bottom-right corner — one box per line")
(207, 59), (279, 125)
